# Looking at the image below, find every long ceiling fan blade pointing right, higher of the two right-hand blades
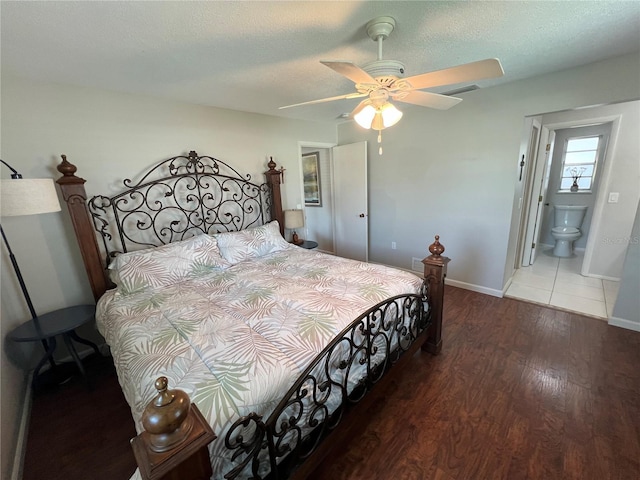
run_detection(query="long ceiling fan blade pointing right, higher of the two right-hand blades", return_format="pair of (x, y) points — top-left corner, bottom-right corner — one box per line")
(401, 58), (504, 90)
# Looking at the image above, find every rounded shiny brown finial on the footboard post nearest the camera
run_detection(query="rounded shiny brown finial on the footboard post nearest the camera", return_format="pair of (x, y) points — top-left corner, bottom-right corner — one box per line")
(142, 377), (193, 453)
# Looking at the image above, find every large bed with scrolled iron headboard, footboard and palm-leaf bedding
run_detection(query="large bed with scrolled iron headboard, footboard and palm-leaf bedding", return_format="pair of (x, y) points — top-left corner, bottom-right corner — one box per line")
(58, 151), (448, 479)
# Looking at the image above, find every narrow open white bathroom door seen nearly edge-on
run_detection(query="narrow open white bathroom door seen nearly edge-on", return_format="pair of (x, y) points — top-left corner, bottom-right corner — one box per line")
(522, 127), (555, 266)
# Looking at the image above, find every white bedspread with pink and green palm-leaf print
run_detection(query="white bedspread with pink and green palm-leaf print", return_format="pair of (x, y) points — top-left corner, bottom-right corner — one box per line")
(96, 247), (422, 478)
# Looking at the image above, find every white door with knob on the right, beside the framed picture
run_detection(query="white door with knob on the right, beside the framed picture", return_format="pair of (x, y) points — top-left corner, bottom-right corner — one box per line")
(332, 142), (369, 262)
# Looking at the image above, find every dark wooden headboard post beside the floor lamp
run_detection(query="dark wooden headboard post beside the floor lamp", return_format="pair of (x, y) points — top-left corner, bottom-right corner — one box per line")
(56, 155), (108, 300)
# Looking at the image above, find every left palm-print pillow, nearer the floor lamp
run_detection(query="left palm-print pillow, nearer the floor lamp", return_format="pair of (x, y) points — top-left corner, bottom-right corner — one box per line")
(109, 234), (231, 294)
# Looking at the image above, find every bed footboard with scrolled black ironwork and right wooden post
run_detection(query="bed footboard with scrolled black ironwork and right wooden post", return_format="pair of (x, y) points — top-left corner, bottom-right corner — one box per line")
(124, 242), (449, 480)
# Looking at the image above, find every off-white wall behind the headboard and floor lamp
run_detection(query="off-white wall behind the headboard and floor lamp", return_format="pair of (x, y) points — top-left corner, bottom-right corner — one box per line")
(0, 74), (336, 478)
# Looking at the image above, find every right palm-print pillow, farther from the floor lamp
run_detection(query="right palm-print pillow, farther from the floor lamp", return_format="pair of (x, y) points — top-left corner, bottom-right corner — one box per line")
(215, 220), (291, 265)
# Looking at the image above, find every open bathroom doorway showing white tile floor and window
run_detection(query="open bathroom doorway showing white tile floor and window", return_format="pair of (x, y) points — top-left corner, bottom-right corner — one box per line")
(505, 117), (612, 318)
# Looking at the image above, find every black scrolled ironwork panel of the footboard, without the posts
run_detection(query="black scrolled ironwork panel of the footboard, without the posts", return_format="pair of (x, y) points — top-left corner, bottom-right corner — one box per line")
(225, 283), (431, 479)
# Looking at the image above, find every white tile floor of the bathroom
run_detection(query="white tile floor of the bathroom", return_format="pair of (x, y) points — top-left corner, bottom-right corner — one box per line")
(505, 249), (619, 319)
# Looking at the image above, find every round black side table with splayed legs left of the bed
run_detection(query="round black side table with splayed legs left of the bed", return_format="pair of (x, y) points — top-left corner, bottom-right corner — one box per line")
(7, 305), (100, 390)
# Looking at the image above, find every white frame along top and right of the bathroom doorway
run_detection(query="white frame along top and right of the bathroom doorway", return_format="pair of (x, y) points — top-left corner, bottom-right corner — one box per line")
(518, 115), (621, 276)
